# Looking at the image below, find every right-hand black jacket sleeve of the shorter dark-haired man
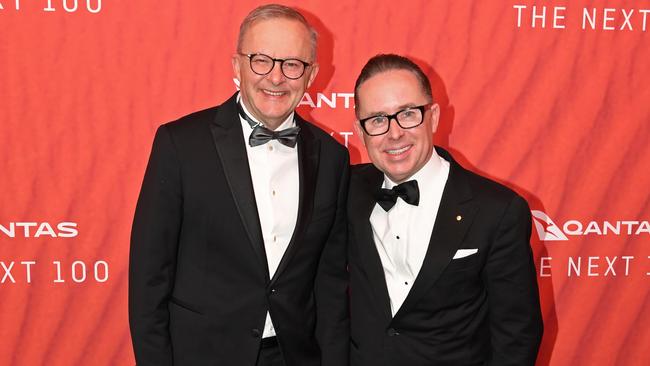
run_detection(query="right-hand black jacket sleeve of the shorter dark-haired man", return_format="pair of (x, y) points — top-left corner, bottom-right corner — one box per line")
(484, 196), (543, 366)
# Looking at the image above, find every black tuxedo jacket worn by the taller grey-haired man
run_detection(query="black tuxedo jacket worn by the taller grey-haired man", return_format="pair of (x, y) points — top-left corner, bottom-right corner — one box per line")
(129, 96), (349, 366)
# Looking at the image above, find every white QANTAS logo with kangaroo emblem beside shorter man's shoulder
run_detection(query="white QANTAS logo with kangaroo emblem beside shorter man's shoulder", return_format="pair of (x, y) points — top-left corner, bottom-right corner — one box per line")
(531, 210), (650, 241)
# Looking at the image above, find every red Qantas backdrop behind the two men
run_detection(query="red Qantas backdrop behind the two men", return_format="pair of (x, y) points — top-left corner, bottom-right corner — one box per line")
(0, 0), (650, 365)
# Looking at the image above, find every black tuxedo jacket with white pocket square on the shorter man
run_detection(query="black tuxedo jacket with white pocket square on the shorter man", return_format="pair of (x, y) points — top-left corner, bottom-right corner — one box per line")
(348, 149), (542, 366)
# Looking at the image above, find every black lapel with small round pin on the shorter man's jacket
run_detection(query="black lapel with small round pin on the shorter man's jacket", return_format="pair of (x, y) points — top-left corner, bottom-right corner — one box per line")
(395, 159), (478, 318)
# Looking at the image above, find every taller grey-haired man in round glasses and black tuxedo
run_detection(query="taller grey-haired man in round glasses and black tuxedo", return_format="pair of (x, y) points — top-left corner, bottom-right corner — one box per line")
(129, 5), (349, 366)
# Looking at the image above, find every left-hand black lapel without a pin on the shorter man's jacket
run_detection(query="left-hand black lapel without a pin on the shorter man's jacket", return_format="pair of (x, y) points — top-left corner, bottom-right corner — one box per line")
(348, 165), (392, 319)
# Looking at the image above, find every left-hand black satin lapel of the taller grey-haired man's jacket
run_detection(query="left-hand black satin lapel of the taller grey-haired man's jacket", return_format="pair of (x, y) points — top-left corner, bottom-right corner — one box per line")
(210, 96), (269, 278)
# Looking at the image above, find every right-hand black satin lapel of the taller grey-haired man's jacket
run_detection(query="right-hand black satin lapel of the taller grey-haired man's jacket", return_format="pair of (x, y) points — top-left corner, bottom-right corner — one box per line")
(271, 118), (320, 285)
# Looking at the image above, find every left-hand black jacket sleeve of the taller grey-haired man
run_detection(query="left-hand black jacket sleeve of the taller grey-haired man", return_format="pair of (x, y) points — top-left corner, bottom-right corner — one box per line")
(129, 125), (182, 366)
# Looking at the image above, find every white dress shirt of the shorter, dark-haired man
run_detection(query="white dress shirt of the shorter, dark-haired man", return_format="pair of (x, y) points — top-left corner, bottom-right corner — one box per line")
(370, 150), (449, 316)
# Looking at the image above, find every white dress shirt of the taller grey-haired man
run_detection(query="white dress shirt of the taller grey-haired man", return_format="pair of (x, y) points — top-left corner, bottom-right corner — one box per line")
(238, 98), (300, 338)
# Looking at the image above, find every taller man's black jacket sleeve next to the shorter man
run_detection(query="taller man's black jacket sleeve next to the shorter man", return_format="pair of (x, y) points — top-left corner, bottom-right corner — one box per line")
(314, 151), (350, 366)
